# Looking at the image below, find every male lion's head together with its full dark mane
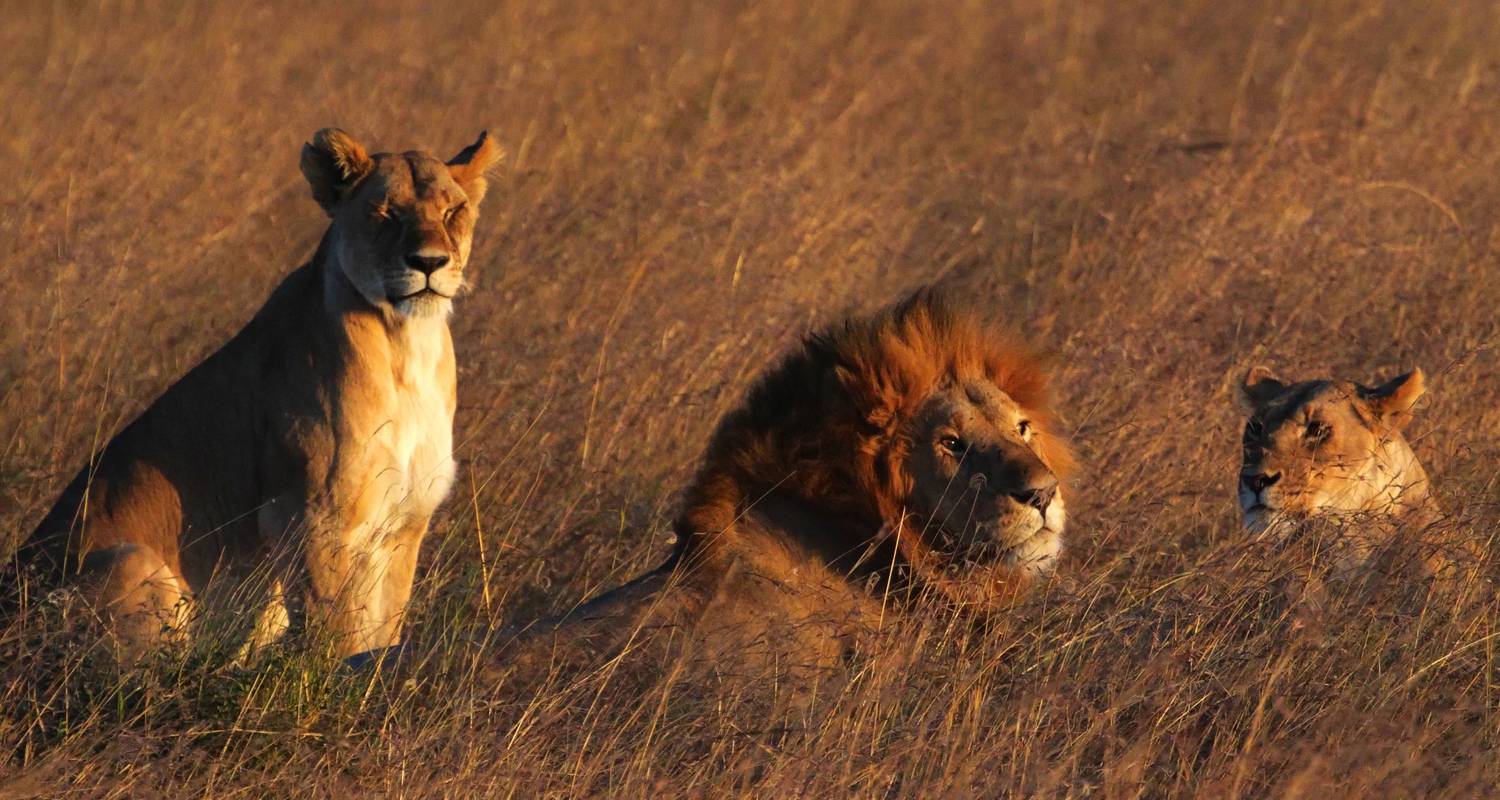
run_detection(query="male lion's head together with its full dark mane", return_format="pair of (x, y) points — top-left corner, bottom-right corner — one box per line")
(675, 291), (1074, 605)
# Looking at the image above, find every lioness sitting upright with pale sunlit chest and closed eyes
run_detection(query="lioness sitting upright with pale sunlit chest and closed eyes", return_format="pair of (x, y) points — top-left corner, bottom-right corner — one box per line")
(18, 129), (501, 654)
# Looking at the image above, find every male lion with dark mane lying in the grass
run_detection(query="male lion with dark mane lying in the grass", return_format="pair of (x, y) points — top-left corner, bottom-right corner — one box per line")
(510, 293), (1073, 665)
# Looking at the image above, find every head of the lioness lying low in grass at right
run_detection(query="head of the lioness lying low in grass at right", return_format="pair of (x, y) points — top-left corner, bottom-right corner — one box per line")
(1238, 369), (1424, 533)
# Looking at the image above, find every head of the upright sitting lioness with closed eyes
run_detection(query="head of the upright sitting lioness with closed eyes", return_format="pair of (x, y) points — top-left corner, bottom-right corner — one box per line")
(303, 131), (500, 318)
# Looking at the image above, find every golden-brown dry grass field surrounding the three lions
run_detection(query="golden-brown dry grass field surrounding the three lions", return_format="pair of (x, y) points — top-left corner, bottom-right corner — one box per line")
(0, 0), (1500, 800)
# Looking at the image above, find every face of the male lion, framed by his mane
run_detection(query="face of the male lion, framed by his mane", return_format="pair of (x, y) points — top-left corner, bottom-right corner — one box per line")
(909, 380), (1065, 575)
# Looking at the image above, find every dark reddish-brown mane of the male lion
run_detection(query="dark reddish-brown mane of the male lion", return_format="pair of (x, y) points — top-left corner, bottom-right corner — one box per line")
(674, 290), (1074, 560)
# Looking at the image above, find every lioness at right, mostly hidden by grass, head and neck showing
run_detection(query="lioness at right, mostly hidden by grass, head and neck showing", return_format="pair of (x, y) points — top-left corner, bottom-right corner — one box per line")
(1238, 366), (1467, 576)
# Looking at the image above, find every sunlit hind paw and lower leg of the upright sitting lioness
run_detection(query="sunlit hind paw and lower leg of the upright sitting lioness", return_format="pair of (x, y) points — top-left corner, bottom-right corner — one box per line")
(83, 545), (191, 659)
